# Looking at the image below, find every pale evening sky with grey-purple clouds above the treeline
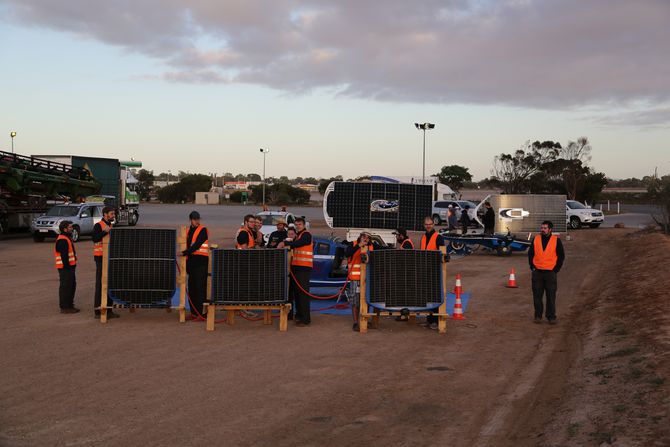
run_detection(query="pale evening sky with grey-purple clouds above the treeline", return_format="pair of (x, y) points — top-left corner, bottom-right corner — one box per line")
(0, 0), (670, 179)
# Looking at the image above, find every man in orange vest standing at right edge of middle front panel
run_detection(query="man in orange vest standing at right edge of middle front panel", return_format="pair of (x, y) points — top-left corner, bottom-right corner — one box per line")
(284, 217), (314, 326)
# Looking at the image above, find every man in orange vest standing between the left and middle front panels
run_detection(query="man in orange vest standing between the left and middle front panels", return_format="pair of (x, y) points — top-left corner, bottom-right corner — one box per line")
(181, 211), (209, 319)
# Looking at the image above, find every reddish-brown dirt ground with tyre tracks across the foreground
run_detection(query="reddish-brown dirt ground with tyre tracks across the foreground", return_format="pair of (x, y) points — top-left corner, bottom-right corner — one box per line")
(0, 228), (670, 446)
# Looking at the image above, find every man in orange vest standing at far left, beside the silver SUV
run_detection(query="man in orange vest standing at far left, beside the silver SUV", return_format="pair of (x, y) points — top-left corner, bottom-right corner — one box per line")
(54, 220), (79, 314)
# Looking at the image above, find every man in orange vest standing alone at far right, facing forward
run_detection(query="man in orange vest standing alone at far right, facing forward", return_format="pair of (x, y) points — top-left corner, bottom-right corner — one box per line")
(528, 220), (565, 324)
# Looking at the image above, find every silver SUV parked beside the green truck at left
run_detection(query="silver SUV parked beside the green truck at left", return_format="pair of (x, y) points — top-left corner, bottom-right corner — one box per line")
(30, 202), (105, 242)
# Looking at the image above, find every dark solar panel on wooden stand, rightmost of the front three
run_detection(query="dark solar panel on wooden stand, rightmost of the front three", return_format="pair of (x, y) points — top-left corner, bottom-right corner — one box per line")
(366, 250), (444, 309)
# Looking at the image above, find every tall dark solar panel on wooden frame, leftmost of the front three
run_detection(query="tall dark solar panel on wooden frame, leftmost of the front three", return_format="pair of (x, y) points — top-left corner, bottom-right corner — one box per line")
(107, 228), (176, 307)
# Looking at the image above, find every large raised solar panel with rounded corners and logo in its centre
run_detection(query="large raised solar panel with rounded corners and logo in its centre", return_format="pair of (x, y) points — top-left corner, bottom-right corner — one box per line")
(326, 182), (433, 231)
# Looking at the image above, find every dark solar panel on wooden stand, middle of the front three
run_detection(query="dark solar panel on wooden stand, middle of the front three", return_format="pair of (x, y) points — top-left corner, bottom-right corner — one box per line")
(212, 249), (288, 305)
